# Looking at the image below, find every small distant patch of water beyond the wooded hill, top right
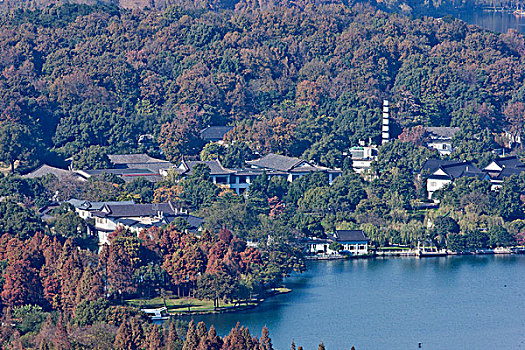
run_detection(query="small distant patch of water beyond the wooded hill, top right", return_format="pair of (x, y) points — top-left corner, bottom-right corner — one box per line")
(457, 10), (525, 33)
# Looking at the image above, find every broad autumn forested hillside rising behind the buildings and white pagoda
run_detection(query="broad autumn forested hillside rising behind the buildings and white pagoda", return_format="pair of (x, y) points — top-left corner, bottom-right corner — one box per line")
(0, 1), (525, 171)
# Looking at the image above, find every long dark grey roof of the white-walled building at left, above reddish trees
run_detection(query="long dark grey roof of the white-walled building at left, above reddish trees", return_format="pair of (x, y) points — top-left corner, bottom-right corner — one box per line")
(97, 203), (178, 218)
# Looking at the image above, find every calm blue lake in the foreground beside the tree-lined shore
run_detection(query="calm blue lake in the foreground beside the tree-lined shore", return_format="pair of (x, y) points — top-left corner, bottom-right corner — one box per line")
(183, 255), (525, 350)
